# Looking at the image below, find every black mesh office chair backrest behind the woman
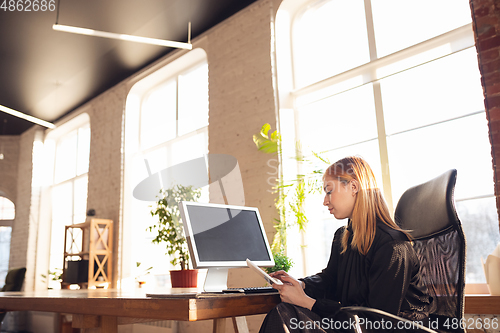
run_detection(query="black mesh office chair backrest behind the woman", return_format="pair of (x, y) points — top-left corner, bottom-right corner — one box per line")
(395, 169), (466, 331)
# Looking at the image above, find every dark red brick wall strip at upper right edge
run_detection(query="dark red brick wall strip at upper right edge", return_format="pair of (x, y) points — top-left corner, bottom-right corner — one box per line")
(469, 0), (500, 228)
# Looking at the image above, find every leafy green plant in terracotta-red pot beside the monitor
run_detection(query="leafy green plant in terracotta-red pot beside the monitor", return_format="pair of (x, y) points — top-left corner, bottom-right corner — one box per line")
(148, 185), (201, 288)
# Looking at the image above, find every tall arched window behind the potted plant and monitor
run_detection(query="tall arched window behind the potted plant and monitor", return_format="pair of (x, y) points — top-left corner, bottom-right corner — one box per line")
(125, 49), (208, 288)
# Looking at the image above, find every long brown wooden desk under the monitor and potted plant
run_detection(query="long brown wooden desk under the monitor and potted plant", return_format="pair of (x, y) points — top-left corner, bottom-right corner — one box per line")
(0, 289), (280, 333)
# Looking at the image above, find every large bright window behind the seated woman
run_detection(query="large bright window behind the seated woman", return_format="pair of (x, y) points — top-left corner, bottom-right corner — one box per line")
(277, 0), (500, 283)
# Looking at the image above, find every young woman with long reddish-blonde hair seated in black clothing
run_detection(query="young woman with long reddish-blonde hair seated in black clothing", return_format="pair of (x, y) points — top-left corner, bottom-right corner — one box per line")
(260, 157), (431, 332)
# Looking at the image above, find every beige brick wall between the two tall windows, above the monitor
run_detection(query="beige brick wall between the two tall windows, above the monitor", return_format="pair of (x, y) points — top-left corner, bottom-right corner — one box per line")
(206, 1), (276, 253)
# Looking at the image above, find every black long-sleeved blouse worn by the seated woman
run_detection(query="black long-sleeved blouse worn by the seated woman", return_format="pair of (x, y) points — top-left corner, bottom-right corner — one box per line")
(301, 222), (432, 320)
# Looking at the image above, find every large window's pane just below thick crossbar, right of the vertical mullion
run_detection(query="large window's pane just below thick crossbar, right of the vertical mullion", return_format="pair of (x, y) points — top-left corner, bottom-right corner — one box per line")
(380, 48), (486, 134)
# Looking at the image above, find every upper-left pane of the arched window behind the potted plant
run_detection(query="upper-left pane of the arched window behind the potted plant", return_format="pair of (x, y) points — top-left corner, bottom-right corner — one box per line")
(141, 81), (177, 149)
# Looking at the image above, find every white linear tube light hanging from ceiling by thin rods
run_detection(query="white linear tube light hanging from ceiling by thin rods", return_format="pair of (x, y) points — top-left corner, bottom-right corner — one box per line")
(52, 0), (193, 50)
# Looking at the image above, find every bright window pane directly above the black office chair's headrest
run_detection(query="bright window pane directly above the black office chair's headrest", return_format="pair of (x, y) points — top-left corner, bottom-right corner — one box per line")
(388, 113), (493, 202)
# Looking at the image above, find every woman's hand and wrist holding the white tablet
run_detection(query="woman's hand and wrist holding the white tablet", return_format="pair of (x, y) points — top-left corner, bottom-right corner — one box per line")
(269, 271), (316, 310)
